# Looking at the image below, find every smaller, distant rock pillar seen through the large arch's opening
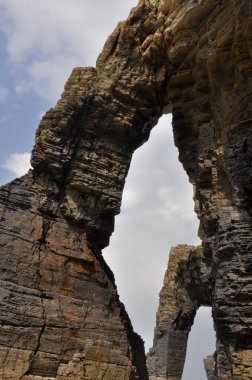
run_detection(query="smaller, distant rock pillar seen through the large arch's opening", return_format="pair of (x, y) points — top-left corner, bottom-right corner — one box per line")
(147, 245), (211, 380)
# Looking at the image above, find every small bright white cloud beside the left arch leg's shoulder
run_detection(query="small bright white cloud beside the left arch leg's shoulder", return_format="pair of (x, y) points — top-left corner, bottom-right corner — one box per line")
(1, 153), (31, 177)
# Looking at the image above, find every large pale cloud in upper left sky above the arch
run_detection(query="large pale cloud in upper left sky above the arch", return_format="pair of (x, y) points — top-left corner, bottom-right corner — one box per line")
(0, 0), (136, 102)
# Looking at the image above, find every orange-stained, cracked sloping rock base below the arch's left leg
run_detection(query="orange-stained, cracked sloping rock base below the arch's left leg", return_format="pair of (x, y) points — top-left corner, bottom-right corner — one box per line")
(0, 172), (147, 380)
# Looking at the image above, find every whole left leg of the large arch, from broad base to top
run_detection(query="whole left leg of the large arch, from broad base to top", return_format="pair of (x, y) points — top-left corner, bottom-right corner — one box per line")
(0, 3), (164, 380)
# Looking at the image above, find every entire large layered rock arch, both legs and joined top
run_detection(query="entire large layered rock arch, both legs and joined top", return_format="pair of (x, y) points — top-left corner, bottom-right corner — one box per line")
(0, 0), (252, 380)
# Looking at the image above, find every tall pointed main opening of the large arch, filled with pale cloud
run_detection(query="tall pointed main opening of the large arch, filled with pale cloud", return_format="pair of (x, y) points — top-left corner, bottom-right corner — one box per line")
(104, 115), (200, 352)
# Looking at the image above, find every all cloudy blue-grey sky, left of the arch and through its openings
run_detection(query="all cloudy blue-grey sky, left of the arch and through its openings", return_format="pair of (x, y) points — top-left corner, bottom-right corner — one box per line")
(0, 0), (214, 380)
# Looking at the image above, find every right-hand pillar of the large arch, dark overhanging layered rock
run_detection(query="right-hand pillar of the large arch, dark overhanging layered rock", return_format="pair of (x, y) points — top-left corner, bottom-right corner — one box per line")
(161, 1), (252, 380)
